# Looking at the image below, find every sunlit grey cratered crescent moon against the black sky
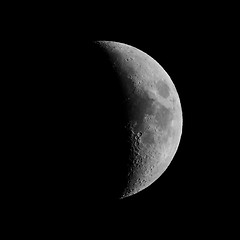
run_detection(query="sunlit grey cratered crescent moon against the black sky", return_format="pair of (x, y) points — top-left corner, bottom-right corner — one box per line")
(86, 41), (182, 198)
